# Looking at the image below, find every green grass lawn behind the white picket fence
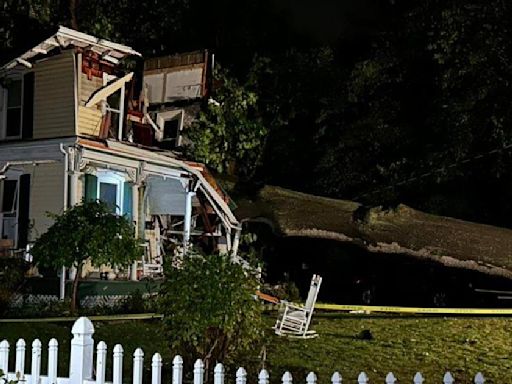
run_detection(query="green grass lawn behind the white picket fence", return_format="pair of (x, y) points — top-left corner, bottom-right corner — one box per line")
(0, 314), (512, 384)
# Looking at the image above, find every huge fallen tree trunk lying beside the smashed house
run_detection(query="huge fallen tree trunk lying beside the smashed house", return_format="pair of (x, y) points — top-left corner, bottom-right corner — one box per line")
(236, 186), (512, 278)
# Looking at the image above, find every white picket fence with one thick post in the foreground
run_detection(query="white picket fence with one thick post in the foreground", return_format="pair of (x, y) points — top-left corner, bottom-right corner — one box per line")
(0, 317), (485, 384)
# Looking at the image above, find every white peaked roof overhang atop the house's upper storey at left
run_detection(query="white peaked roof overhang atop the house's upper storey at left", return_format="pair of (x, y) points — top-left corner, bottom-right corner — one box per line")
(0, 26), (142, 73)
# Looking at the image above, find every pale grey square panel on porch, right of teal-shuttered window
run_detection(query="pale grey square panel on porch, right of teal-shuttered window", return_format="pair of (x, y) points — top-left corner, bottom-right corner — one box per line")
(147, 176), (186, 216)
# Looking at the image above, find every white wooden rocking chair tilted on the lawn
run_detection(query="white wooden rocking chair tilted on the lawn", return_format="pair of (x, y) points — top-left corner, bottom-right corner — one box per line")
(274, 275), (322, 339)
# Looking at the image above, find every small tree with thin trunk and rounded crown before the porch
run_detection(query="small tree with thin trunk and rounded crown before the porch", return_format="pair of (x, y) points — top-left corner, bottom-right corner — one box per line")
(32, 201), (140, 312)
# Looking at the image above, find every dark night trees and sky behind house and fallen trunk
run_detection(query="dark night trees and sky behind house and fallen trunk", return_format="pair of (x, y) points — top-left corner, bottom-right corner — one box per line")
(0, 0), (512, 226)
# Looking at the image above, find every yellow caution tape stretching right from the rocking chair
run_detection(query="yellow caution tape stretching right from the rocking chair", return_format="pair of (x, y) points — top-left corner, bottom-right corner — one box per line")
(315, 304), (512, 315)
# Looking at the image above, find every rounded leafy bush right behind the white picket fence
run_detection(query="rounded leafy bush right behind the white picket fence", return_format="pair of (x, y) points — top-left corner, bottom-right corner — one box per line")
(160, 251), (262, 368)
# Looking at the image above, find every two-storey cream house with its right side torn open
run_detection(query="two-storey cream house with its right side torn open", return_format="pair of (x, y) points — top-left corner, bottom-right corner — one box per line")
(0, 27), (241, 279)
